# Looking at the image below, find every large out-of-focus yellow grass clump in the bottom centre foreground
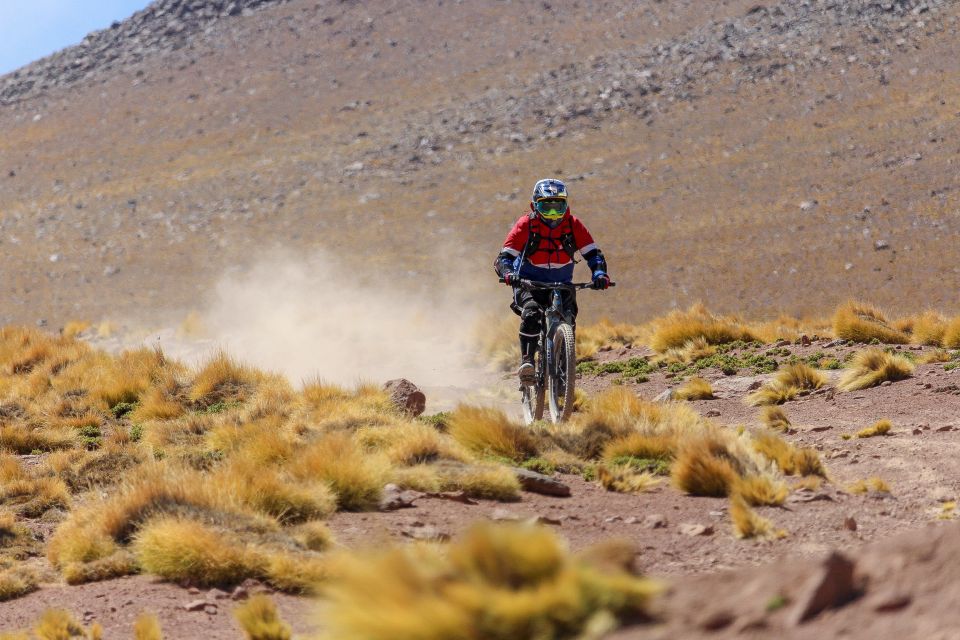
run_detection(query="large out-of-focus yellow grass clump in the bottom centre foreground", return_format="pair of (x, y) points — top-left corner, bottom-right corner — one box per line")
(322, 524), (659, 640)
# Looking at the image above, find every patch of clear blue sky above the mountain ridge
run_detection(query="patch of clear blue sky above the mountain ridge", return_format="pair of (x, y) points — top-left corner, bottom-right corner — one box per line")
(0, 0), (150, 75)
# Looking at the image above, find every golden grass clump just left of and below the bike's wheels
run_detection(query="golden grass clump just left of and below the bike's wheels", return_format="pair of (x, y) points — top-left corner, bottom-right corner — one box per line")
(447, 405), (537, 461)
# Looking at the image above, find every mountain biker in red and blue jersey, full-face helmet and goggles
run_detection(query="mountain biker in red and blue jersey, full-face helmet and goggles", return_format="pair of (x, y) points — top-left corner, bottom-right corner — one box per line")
(494, 178), (610, 385)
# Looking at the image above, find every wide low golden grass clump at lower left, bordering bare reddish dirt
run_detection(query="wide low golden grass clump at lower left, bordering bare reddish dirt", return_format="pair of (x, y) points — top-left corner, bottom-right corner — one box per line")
(133, 517), (265, 587)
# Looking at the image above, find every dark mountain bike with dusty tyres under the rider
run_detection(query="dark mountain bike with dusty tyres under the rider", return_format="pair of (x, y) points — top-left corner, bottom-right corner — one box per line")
(500, 278), (616, 424)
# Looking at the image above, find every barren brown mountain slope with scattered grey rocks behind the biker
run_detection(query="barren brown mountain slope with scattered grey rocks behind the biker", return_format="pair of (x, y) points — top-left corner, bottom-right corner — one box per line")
(0, 0), (960, 322)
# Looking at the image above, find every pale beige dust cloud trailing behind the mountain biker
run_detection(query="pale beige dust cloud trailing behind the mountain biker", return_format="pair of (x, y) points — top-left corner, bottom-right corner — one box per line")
(191, 254), (488, 386)
